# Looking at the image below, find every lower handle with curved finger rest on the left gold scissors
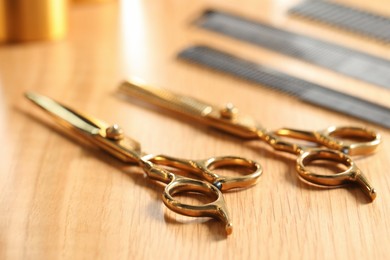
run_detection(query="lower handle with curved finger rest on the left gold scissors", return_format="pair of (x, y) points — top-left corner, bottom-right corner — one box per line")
(141, 160), (233, 235)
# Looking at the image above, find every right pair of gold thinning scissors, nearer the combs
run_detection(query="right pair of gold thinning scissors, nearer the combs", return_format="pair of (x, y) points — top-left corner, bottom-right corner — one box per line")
(119, 78), (381, 201)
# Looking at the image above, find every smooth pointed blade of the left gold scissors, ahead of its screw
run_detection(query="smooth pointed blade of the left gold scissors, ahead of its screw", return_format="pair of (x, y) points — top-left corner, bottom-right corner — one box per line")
(25, 92), (102, 136)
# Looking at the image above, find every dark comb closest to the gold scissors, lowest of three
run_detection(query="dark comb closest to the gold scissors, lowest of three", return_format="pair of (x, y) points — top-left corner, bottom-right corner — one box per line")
(178, 46), (390, 128)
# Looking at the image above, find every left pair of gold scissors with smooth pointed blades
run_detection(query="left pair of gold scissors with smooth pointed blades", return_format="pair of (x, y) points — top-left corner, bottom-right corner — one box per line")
(26, 92), (262, 234)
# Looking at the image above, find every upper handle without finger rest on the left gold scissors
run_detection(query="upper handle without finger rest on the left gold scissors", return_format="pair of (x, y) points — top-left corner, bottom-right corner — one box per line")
(143, 155), (263, 191)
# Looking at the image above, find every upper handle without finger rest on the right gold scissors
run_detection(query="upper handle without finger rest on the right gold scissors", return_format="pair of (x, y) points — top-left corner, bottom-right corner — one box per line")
(275, 126), (381, 155)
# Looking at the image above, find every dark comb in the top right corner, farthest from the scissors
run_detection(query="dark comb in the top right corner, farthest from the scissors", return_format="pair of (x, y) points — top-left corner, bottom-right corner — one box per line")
(289, 1), (390, 43)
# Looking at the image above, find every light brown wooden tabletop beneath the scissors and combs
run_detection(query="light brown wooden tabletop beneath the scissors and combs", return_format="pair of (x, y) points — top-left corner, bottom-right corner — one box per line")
(0, 0), (390, 259)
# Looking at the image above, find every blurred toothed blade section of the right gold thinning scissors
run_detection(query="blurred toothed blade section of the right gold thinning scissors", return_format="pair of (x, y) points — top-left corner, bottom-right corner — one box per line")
(119, 77), (259, 139)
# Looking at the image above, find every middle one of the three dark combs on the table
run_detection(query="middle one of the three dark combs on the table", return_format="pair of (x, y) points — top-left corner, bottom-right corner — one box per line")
(196, 10), (390, 89)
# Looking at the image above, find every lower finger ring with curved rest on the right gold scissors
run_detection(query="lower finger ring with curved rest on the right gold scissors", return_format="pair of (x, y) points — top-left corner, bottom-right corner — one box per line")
(296, 149), (376, 201)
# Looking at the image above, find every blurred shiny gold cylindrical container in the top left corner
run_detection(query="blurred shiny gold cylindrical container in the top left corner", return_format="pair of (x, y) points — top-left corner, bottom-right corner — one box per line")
(0, 0), (68, 42)
